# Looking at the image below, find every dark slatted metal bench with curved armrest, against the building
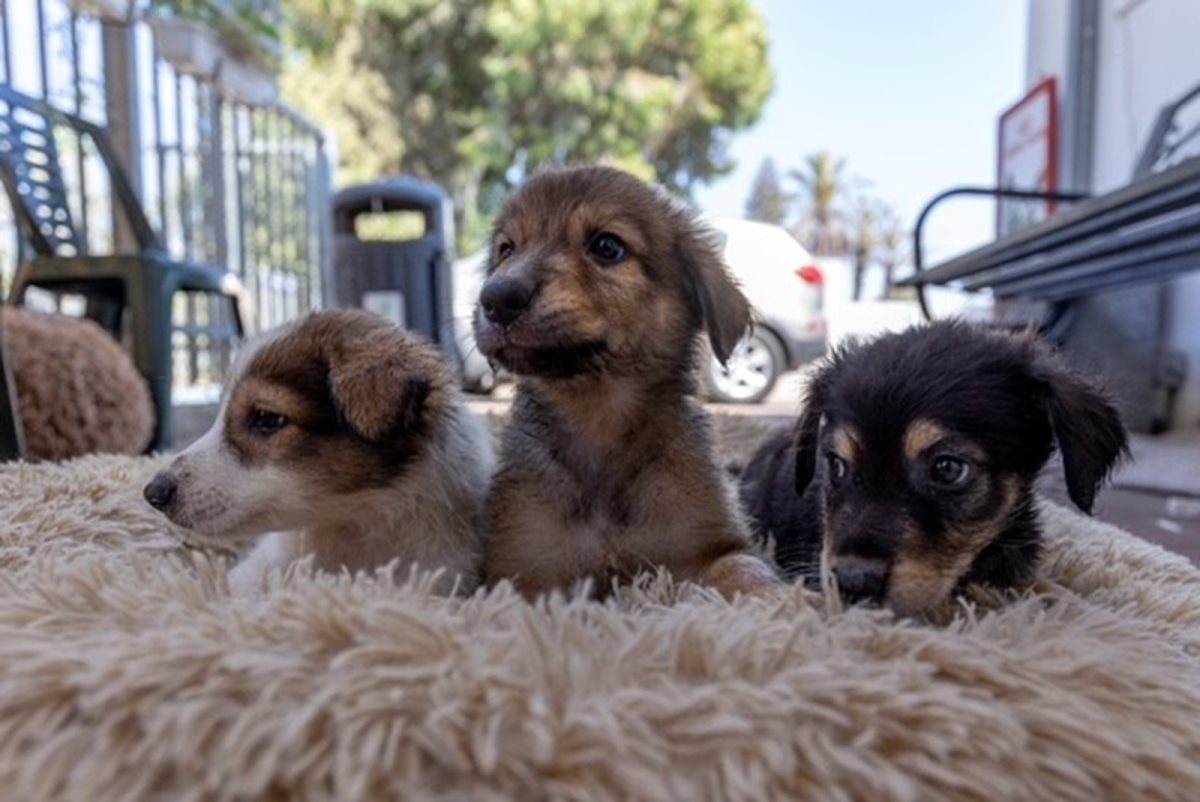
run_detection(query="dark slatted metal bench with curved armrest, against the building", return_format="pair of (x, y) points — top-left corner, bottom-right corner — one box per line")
(895, 81), (1200, 333)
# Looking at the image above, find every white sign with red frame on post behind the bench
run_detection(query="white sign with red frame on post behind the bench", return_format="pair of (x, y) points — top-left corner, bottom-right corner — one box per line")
(996, 78), (1058, 239)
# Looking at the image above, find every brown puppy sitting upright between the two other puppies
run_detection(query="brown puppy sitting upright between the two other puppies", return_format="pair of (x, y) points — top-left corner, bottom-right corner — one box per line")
(475, 167), (779, 597)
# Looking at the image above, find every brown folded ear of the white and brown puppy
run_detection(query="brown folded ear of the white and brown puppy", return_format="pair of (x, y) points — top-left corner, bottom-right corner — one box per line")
(329, 333), (433, 442)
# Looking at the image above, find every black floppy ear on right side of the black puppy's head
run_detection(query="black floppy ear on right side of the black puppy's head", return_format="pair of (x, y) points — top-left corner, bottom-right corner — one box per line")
(1034, 346), (1129, 513)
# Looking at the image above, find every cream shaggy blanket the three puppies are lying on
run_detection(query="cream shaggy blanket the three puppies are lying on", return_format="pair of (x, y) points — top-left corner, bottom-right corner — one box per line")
(0, 417), (1200, 801)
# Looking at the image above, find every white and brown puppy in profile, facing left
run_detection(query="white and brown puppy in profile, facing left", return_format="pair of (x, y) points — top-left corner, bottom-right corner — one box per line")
(144, 310), (494, 592)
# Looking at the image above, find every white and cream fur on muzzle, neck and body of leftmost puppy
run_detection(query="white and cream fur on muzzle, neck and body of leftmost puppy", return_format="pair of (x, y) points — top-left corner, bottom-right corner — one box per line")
(156, 331), (496, 593)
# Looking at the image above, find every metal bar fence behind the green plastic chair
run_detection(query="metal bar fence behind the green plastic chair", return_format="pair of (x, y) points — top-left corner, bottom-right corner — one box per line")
(0, 0), (330, 387)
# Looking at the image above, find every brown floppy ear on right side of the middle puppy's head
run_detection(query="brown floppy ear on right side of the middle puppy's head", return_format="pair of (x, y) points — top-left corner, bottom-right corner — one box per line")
(678, 221), (750, 365)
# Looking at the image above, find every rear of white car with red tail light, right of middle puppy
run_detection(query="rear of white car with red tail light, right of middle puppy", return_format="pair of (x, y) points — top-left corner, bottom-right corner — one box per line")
(703, 217), (826, 403)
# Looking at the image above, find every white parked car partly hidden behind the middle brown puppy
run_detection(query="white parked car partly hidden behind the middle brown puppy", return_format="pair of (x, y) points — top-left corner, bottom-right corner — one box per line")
(454, 219), (826, 403)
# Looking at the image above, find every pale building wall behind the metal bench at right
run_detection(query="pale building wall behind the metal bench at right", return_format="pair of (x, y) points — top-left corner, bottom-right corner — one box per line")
(1026, 0), (1200, 427)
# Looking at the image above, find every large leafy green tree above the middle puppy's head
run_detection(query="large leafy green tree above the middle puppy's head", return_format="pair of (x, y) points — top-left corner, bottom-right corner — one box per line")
(284, 0), (773, 250)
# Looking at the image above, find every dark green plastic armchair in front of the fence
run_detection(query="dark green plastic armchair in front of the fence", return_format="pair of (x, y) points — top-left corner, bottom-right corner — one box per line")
(0, 84), (244, 450)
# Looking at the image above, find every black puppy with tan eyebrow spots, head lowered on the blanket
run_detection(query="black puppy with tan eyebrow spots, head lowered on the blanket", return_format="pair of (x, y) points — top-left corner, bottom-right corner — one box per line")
(742, 322), (1128, 615)
